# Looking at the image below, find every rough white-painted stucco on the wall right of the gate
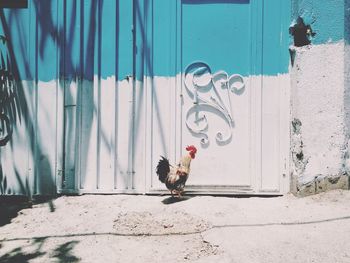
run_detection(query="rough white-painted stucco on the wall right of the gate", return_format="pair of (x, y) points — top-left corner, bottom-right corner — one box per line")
(291, 41), (350, 190)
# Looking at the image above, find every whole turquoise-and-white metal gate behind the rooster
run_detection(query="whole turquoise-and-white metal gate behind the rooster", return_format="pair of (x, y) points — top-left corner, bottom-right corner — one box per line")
(0, 0), (290, 195)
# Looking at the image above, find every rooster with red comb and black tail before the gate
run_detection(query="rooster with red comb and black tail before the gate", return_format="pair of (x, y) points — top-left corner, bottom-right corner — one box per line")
(156, 145), (197, 198)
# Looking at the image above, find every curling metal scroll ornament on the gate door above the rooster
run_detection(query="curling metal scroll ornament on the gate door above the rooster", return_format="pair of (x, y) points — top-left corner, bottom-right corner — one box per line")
(184, 62), (245, 146)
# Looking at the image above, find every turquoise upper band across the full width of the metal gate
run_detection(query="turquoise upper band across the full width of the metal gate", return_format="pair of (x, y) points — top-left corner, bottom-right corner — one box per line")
(2, 0), (290, 81)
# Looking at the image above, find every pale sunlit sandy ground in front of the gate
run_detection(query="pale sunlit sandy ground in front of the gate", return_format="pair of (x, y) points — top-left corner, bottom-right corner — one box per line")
(0, 190), (350, 263)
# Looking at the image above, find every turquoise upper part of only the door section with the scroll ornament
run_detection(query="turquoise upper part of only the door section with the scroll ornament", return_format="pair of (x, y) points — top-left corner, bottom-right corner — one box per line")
(141, 0), (290, 77)
